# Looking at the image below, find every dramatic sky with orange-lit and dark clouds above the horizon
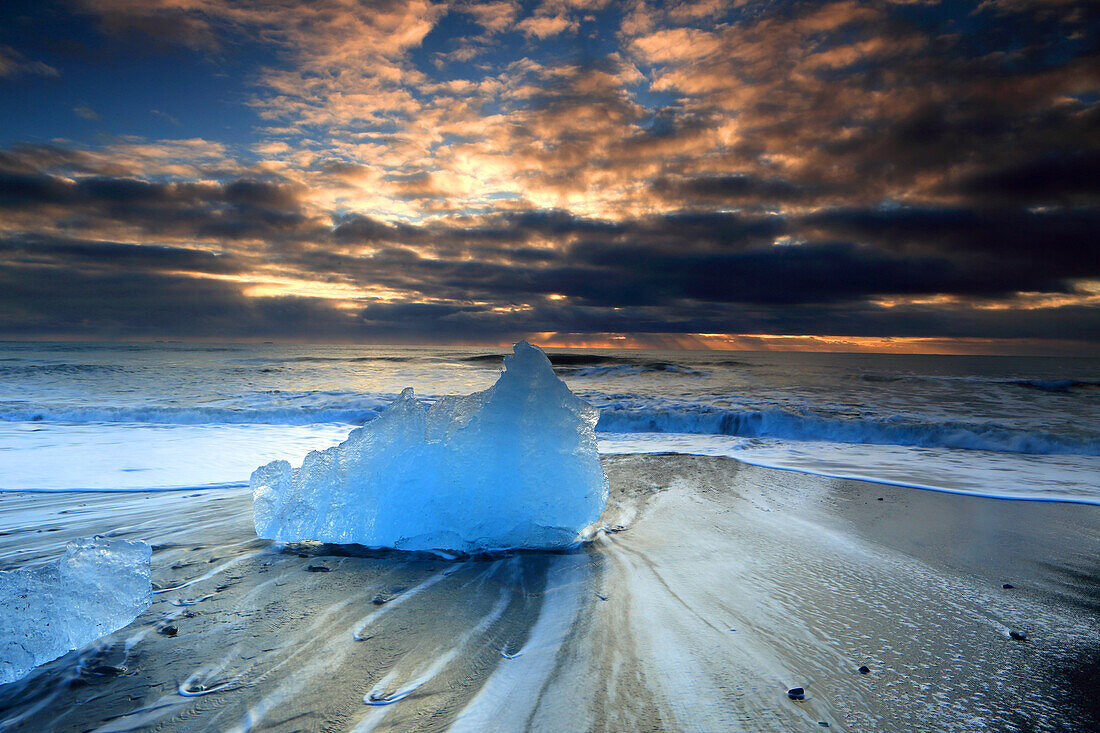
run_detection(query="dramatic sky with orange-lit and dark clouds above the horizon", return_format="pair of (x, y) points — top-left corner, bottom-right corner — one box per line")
(0, 0), (1100, 355)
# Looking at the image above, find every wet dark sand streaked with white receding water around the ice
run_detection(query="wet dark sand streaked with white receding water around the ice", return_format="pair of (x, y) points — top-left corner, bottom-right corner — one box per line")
(0, 456), (1100, 733)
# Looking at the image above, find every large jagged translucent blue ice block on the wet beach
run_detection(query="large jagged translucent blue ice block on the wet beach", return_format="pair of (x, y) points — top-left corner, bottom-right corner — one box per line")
(251, 341), (607, 553)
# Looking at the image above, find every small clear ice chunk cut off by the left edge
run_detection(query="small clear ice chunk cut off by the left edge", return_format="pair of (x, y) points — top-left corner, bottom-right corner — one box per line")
(0, 538), (153, 685)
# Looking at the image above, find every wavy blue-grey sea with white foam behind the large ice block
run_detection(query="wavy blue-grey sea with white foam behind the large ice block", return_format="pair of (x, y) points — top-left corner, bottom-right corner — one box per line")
(0, 341), (1100, 504)
